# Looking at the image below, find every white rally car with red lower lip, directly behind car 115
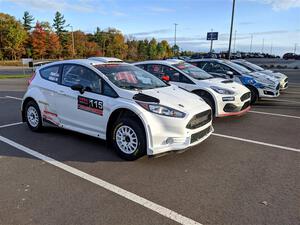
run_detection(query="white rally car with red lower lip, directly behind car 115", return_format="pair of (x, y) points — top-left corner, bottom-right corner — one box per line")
(134, 59), (251, 117)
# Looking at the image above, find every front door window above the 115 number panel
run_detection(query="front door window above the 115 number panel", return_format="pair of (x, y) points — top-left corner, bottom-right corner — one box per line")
(61, 65), (101, 94)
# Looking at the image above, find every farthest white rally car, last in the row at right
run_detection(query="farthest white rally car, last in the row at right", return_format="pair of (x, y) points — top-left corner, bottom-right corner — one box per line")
(232, 60), (288, 90)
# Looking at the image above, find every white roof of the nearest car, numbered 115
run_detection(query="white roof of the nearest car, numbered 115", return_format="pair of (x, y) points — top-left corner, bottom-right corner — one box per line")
(37, 57), (124, 68)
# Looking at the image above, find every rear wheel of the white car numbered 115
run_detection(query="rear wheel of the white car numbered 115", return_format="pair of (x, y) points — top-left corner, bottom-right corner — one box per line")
(25, 101), (43, 131)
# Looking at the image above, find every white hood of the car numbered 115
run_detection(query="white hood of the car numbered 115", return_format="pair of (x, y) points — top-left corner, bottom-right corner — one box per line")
(121, 85), (210, 113)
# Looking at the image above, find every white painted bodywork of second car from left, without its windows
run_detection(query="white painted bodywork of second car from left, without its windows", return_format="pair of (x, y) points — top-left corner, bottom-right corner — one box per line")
(134, 59), (251, 117)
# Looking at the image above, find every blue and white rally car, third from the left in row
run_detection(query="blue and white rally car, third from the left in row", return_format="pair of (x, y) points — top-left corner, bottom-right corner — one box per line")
(189, 59), (280, 104)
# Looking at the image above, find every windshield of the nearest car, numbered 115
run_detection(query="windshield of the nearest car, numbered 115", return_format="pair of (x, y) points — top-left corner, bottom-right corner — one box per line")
(94, 64), (168, 90)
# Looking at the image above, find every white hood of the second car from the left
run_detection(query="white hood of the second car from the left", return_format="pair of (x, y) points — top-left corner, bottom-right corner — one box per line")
(194, 78), (248, 92)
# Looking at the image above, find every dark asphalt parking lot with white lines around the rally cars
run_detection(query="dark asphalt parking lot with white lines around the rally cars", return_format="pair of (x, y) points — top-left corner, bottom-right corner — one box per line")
(0, 73), (300, 225)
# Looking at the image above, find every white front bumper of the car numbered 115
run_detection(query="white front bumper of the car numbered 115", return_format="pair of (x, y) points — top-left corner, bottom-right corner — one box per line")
(147, 109), (213, 156)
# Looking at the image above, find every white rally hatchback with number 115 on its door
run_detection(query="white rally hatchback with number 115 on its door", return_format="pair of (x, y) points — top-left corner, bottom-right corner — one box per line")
(22, 57), (213, 160)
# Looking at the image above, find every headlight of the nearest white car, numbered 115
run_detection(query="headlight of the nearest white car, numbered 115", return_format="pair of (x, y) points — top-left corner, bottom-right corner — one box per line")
(136, 102), (185, 118)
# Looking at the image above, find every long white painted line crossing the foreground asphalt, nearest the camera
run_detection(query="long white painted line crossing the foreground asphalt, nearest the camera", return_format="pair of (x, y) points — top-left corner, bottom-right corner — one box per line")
(0, 136), (201, 225)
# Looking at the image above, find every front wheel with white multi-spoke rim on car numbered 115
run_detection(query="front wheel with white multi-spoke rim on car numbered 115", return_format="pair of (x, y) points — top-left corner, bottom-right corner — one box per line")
(112, 117), (146, 160)
